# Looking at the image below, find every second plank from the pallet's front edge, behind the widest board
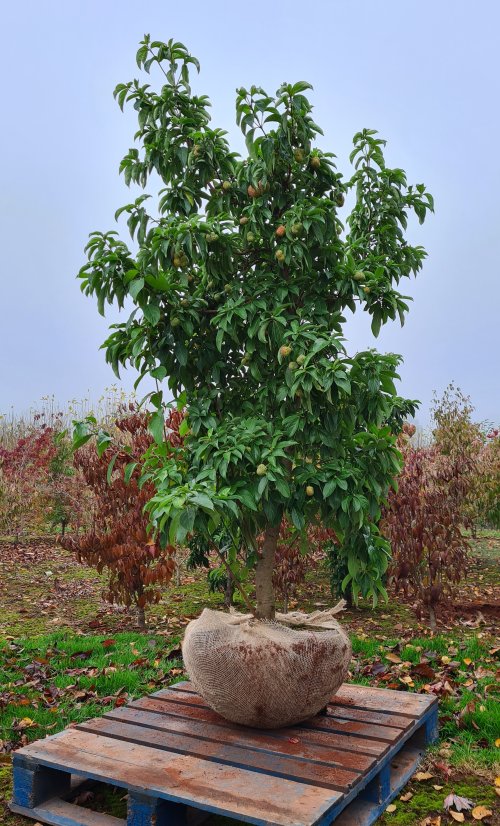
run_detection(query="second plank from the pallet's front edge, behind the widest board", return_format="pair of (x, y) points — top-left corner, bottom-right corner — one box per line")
(75, 718), (360, 791)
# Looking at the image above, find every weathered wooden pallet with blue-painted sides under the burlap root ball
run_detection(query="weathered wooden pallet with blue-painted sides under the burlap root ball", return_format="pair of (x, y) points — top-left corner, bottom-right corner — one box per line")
(11, 683), (437, 826)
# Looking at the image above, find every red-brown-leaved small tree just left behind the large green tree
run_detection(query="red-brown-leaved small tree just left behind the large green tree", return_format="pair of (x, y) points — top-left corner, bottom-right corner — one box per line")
(61, 405), (180, 628)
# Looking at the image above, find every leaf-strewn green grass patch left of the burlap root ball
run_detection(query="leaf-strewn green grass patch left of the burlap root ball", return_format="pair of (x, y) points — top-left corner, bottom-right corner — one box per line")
(0, 633), (182, 746)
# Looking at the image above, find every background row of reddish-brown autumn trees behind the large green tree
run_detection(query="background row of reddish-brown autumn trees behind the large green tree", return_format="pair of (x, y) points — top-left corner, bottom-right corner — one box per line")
(0, 385), (500, 625)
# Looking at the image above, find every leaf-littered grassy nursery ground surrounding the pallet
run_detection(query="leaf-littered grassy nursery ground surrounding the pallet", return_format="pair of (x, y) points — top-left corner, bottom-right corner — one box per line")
(0, 531), (500, 826)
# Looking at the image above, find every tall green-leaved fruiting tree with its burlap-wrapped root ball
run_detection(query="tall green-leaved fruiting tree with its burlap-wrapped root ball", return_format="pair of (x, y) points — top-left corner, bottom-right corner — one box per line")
(80, 36), (433, 725)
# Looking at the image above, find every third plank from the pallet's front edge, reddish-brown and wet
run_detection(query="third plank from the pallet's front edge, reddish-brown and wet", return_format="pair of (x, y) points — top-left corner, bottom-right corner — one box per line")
(104, 706), (375, 771)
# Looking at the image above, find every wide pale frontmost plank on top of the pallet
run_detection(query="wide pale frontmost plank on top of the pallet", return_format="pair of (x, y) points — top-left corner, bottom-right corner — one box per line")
(18, 729), (341, 826)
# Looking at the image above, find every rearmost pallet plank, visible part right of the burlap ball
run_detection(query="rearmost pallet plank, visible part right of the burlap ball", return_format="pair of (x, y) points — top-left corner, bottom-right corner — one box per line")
(331, 683), (437, 718)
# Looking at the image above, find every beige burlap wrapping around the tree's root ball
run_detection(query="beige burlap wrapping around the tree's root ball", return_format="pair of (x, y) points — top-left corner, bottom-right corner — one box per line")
(182, 608), (351, 728)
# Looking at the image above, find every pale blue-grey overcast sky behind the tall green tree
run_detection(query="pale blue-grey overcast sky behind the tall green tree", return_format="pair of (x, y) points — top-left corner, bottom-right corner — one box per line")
(0, 0), (500, 424)
